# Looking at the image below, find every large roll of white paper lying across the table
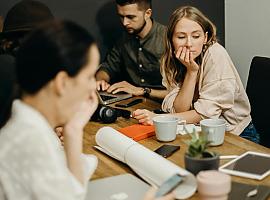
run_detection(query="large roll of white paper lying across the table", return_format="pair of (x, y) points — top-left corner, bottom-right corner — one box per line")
(96, 127), (197, 199)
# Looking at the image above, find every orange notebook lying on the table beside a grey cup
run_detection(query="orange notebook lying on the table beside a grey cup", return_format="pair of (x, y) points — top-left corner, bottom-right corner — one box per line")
(118, 124), (155, 141)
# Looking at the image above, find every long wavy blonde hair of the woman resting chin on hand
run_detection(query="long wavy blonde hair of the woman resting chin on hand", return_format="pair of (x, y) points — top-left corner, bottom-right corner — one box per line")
(161, 6), (217, 86)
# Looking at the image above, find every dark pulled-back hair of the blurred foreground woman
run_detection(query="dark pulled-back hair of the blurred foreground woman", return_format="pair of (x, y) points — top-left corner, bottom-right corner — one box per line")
(17, 20), (94, 94)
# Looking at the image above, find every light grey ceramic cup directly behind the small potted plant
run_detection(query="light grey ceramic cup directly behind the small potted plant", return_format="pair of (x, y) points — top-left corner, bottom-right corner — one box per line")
(200, 119), (226, 146)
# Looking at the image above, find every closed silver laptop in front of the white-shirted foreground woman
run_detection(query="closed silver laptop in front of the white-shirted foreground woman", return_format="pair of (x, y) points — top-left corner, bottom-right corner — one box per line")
(85, 174), (150, 200)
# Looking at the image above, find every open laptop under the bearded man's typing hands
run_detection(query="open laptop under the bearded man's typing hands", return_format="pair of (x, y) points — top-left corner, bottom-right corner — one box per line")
(97, 91), (132, 105)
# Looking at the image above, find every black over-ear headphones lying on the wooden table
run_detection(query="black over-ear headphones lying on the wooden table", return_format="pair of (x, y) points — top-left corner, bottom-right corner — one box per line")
(91, 104), (131, 124)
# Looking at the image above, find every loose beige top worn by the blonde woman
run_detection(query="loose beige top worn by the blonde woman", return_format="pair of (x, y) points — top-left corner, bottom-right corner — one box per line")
(162, 43), (251, 135)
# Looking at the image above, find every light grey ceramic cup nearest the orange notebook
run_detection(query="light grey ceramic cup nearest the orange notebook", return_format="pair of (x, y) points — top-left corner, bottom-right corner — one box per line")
(153, 115), (180, 142)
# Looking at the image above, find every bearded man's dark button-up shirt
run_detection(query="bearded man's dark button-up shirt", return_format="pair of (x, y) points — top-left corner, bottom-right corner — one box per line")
(99, 21), (166, 88)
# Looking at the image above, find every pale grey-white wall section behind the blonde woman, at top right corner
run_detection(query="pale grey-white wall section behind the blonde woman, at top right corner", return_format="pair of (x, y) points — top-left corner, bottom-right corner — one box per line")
(225, 0), (270, 87)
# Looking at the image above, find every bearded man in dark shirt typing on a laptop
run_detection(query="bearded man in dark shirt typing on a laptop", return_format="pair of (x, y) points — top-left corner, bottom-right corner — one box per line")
(96, 0), (167, 98)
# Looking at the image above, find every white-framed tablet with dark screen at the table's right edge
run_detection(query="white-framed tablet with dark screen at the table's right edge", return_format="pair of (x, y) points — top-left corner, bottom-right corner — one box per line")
(219, 151), (270, 180)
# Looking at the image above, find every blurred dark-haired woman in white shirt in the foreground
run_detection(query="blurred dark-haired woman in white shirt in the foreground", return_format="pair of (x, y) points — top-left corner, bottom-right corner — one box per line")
(0, 21), (174, 200)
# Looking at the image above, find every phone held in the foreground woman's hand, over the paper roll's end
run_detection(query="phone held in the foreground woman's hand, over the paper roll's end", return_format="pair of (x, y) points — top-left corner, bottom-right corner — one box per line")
(155, 174), (184, 198)
